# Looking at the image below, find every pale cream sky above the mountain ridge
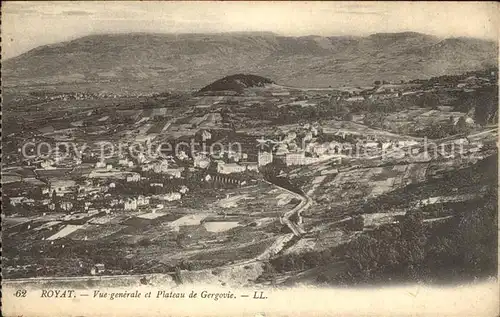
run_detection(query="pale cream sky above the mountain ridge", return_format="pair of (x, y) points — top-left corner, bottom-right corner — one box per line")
(1, 1), (500, 59)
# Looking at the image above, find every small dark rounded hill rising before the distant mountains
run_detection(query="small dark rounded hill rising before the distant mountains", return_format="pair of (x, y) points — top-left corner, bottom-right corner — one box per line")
(200, 74), (274, 92)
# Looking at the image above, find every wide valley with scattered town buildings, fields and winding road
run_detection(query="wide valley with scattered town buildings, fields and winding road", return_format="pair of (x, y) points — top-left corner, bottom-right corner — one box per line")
(2, 68), (498, 283)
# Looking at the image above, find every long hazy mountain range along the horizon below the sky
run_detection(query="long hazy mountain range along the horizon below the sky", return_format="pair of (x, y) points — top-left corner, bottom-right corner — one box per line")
(2, 32), (498, 91)
